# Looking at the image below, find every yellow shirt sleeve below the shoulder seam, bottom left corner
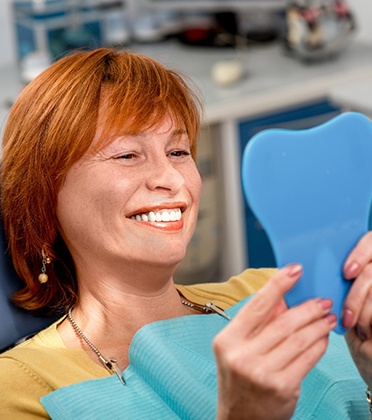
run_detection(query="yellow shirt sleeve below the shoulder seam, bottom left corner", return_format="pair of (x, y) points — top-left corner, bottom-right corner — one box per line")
(0, 356), (52, 420)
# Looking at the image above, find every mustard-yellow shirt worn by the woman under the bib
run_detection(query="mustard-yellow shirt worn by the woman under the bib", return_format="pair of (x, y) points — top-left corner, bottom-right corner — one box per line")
(0, 269), (274, 420)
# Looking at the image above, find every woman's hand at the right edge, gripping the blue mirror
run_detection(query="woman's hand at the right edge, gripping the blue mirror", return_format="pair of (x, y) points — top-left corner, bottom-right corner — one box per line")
(343, 232), (372, 386)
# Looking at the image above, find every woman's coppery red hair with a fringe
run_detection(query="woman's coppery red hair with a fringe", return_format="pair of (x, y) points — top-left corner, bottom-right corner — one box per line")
(1, 48), (201, 312)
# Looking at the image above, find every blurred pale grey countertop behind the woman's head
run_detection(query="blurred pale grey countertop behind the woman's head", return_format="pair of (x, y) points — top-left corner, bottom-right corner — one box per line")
(0, 42), (372, 128)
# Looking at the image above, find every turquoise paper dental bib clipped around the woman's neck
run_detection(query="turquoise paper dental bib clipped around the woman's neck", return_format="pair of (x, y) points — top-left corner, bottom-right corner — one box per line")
(41, 298), (369, 420)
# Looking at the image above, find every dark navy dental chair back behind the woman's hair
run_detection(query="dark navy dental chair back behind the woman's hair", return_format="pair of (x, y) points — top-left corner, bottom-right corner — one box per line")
(0, 218), (55, 352)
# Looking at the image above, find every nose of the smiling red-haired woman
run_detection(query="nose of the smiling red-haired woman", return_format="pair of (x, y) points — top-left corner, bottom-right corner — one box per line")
(147, 156), (185, 193)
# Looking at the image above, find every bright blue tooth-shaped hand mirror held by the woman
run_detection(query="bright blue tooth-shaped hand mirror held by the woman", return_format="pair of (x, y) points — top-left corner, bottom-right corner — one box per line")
(242, 112), (372, 334)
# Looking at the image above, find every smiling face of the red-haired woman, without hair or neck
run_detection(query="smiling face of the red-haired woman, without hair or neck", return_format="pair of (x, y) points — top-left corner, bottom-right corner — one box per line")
(57, 115), (201, 268)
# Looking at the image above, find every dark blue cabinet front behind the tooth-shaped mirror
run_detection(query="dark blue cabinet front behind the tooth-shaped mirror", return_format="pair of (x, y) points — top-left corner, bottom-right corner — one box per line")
(239, 100), (341, 268)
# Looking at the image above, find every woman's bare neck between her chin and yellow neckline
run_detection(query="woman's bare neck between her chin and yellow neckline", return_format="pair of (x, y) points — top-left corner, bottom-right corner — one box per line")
(58, 270), (193, 369)
